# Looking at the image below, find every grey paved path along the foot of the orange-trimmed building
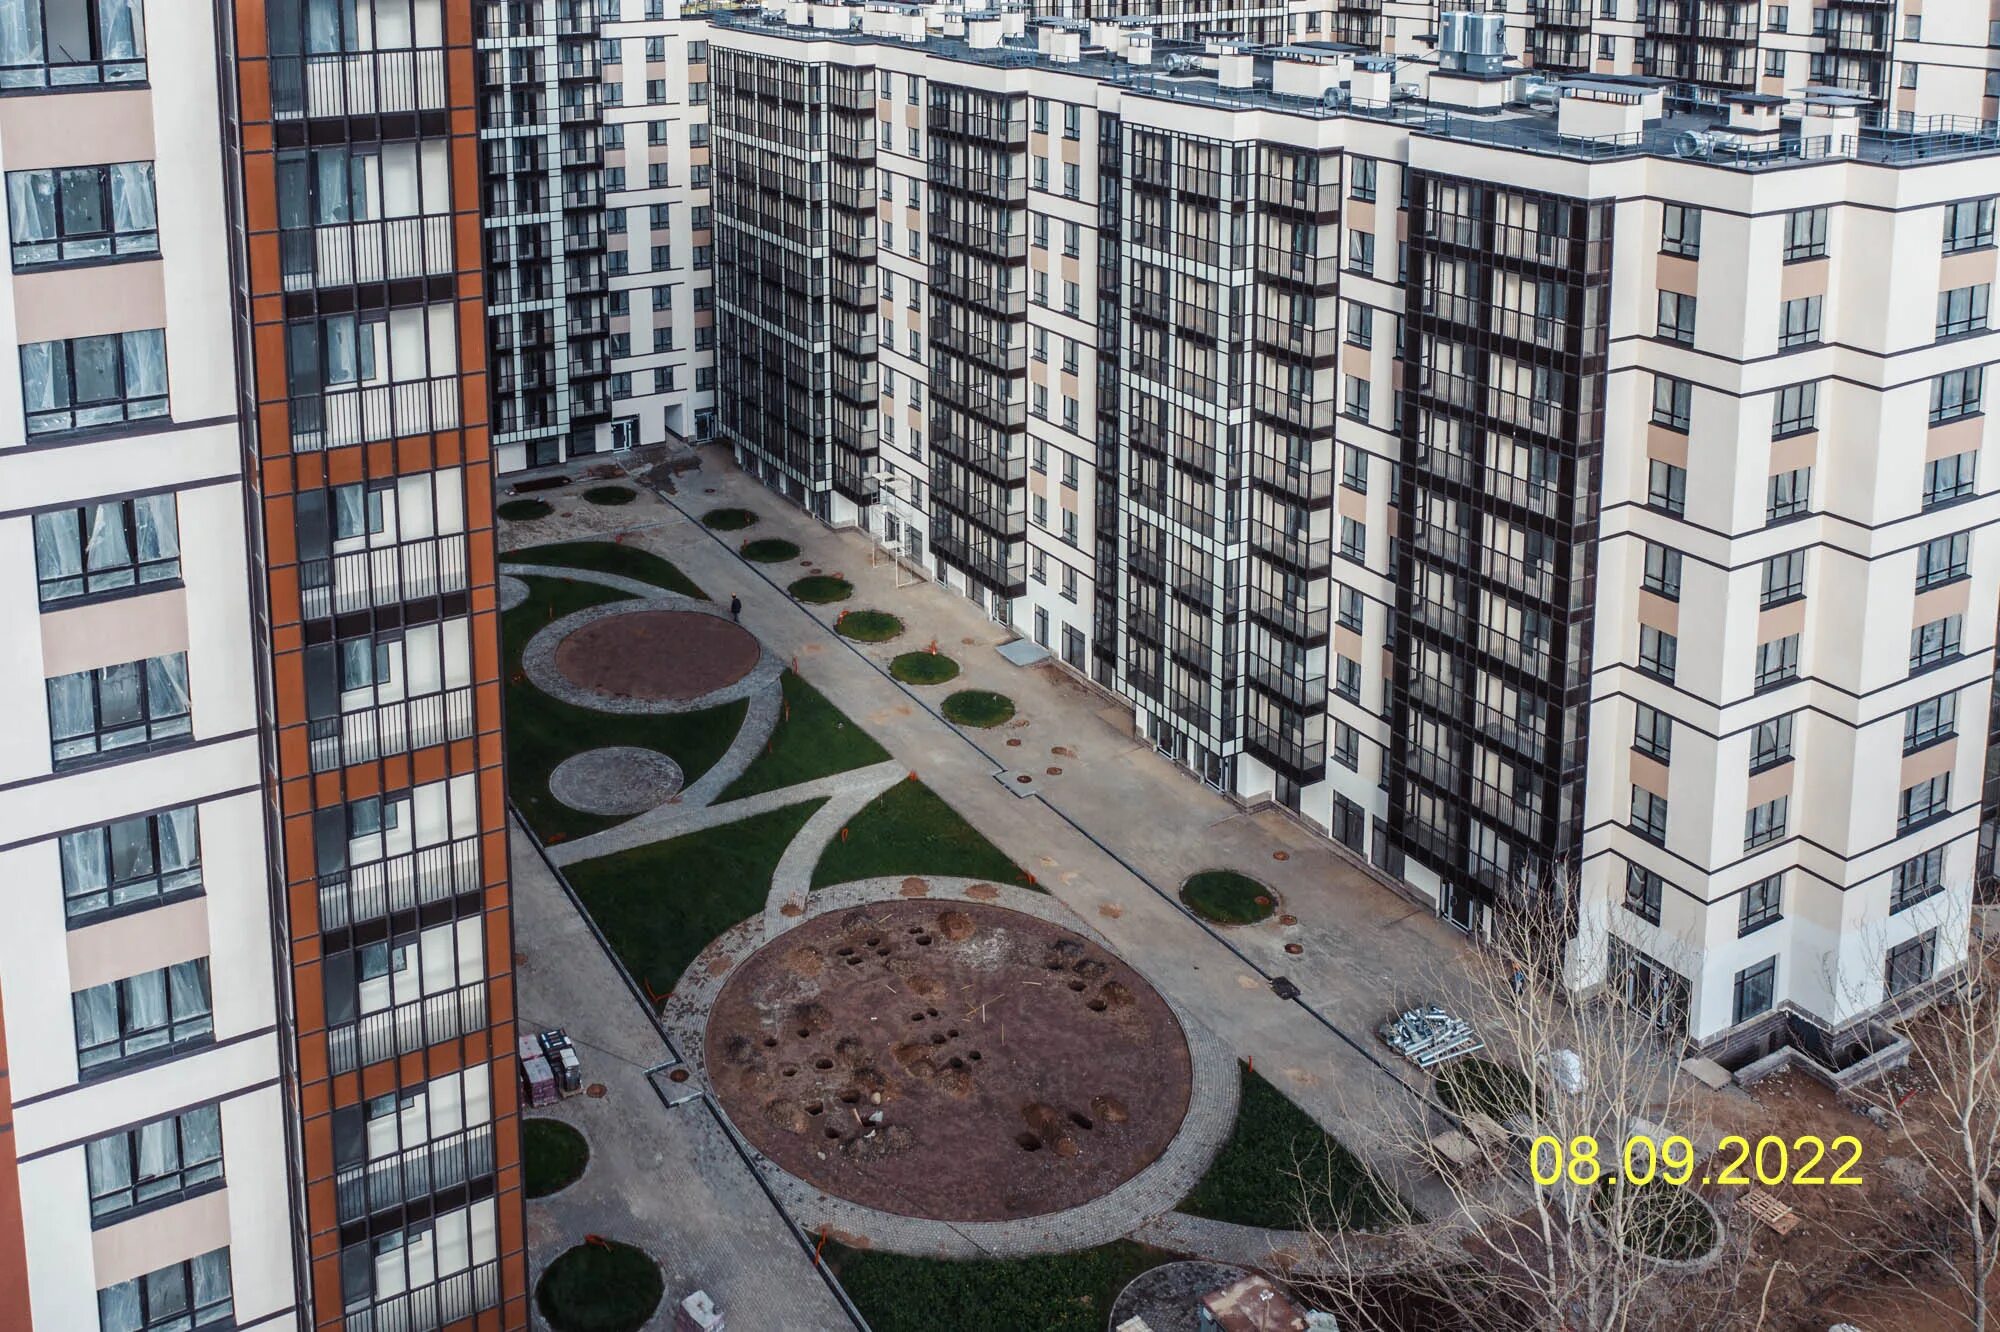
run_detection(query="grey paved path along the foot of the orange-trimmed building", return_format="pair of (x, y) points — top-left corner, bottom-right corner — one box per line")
(506, 820), (848, 1332)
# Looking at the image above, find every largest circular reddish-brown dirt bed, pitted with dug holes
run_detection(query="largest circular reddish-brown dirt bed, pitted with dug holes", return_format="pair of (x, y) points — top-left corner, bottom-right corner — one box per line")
(706, 900), (1192, 1222)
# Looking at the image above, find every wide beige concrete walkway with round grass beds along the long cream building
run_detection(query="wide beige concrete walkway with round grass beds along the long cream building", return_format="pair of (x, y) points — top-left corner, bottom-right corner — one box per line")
(504, 450), (1464, 1214)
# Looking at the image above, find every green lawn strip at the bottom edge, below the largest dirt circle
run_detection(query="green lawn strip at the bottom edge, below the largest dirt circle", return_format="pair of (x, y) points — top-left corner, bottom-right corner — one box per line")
(826, 1240), (1174, 1332)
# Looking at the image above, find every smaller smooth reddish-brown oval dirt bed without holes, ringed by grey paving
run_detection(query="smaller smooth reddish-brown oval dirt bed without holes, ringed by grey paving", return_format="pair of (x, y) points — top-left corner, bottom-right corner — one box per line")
(556, 610), (758, 702)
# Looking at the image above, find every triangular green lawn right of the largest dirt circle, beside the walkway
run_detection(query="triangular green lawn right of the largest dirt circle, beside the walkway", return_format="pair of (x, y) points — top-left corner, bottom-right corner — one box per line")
(1180, 1066), (1396, 1230)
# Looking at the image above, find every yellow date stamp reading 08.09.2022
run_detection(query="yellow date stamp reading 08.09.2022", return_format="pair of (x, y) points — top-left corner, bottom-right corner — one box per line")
(1528, 1134), (1862, 1188)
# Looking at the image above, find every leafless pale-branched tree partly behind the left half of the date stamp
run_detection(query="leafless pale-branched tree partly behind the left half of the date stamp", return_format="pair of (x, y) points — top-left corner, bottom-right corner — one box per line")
(1292, 874), (1756, 1332)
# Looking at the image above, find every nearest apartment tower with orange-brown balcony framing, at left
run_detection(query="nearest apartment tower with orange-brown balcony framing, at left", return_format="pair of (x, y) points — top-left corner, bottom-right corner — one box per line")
(0, 0), (528, 1332)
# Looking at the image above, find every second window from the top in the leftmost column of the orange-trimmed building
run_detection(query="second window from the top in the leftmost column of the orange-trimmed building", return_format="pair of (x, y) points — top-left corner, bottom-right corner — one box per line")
(0, 162), (160, 270)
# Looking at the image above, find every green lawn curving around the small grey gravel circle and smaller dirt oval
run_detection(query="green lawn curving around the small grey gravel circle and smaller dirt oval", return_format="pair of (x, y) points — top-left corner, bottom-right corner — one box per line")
(500, 572), (750, 842)
